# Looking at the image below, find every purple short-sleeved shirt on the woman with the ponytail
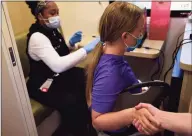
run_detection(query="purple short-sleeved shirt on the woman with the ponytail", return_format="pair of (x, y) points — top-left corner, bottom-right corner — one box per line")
(92, 64), (141, 113)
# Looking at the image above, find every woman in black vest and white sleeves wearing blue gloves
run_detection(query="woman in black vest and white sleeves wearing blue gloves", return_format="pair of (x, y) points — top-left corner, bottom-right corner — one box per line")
(26, 1), (100, 136)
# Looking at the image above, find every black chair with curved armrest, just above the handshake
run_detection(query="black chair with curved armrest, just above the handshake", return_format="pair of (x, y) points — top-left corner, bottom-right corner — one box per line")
(109, 80), (174, 136)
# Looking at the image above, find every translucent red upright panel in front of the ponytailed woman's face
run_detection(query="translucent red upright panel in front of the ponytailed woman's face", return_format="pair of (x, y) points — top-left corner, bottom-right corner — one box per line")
(149, 2), (171, 40)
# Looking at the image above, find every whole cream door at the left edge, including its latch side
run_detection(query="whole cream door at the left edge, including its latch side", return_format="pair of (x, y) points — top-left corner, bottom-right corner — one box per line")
(1, 2), (37, 136)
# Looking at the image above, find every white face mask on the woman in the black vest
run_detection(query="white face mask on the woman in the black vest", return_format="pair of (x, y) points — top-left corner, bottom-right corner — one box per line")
(41, 15), (60, 29)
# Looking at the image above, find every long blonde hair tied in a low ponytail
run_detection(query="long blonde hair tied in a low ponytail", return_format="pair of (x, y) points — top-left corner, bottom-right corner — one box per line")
(86, 2), (143, 105)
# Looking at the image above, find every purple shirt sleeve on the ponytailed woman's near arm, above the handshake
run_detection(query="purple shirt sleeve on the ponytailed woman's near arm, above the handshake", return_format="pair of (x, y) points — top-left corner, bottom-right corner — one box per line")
(92, 69), (122, 113)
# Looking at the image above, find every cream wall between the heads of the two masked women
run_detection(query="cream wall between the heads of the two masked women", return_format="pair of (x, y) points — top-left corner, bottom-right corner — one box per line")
(57, 2), (109, 40)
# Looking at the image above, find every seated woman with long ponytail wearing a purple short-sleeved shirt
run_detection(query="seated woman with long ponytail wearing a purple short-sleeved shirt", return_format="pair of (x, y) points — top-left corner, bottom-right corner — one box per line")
(86, 2), (158, 135)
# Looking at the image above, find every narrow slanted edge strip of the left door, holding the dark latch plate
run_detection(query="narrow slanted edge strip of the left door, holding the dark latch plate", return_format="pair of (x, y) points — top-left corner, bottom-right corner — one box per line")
(1, 2), (38, 136)
